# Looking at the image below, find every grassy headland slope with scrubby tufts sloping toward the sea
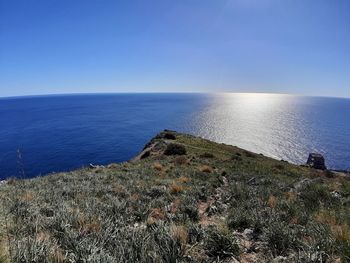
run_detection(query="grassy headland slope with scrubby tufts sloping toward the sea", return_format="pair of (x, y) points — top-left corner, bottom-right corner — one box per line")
(0, 131), (350, 262)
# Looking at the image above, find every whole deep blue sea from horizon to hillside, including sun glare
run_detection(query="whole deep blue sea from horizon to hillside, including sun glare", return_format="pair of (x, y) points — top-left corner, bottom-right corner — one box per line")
(0, 94), (350, 179)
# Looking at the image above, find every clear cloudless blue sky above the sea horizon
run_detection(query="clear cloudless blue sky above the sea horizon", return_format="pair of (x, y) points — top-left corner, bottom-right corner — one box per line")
(0, 0), (350, 97)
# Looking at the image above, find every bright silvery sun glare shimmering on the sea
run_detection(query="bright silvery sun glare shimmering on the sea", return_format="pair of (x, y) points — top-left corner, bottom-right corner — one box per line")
(190, 93), (338, 166)
